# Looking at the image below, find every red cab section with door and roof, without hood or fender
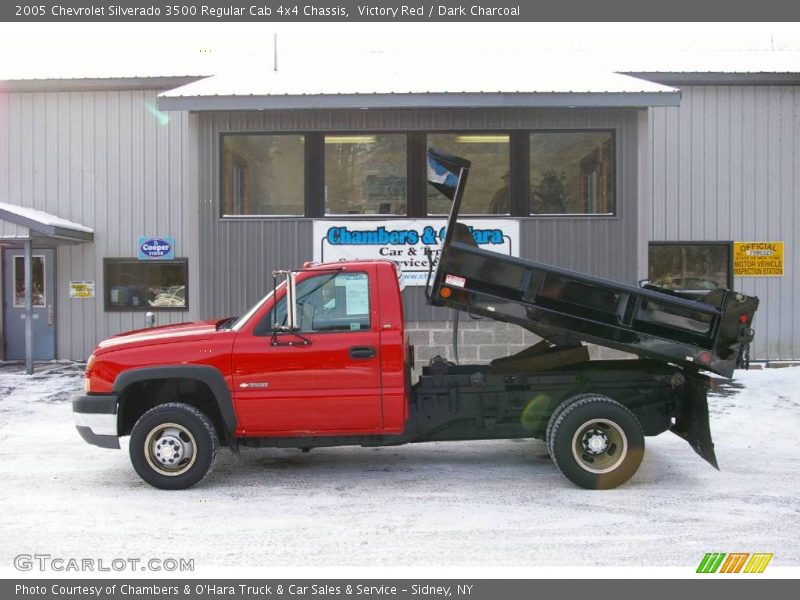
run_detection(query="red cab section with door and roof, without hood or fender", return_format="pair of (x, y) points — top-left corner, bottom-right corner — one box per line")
(231, 261), (410, 436)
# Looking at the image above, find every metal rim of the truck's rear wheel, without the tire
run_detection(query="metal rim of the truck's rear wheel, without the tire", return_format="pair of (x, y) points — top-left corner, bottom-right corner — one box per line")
(572, 419), (628, 474)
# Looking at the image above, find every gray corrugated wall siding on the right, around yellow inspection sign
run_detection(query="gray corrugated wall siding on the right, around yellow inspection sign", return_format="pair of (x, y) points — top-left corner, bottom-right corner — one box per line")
(641, 86), (800, 360)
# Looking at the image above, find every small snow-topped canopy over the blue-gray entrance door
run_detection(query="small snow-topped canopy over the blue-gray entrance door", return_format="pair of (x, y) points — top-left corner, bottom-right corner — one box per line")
(0, 202), (94, 246)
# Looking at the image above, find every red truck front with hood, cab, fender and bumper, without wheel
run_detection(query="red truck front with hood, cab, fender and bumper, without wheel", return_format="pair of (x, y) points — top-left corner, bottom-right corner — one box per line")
(75, 261), (411, 447)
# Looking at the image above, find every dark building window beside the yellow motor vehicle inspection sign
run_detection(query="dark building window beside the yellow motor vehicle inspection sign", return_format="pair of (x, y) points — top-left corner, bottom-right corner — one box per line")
(648, 242), (733, 292)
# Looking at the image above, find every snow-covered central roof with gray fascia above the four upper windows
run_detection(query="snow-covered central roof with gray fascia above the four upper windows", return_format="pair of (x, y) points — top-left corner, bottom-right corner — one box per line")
(158, 68), (680, 111)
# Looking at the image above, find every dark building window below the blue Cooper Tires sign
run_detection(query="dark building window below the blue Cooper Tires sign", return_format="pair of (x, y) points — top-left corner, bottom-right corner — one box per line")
(104, 258), (189, 311)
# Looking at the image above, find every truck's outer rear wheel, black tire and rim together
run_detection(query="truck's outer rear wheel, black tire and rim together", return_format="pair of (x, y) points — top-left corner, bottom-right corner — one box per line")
(548, 395), (644, 490)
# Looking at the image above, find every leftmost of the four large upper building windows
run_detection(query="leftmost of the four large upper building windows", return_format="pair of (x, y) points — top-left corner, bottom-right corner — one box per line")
(222, 134), (305, 216)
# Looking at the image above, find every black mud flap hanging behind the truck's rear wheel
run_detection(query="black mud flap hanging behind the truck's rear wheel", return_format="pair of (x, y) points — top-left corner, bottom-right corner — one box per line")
(670, 373), (719, 470)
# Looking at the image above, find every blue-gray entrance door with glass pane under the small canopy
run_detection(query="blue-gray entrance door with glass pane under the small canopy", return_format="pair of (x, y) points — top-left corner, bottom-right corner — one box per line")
(3, 249), (56, 360)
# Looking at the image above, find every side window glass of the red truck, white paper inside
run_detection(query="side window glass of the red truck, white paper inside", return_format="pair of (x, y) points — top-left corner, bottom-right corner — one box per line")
(255, 273), (370, 335)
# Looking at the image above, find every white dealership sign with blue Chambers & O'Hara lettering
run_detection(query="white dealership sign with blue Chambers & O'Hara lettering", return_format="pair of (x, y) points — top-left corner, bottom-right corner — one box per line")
(314, 219), (519, 285)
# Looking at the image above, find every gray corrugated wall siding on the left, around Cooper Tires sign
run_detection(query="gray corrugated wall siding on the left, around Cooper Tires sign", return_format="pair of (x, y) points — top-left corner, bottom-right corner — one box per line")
(0, 91), (200, 359)
